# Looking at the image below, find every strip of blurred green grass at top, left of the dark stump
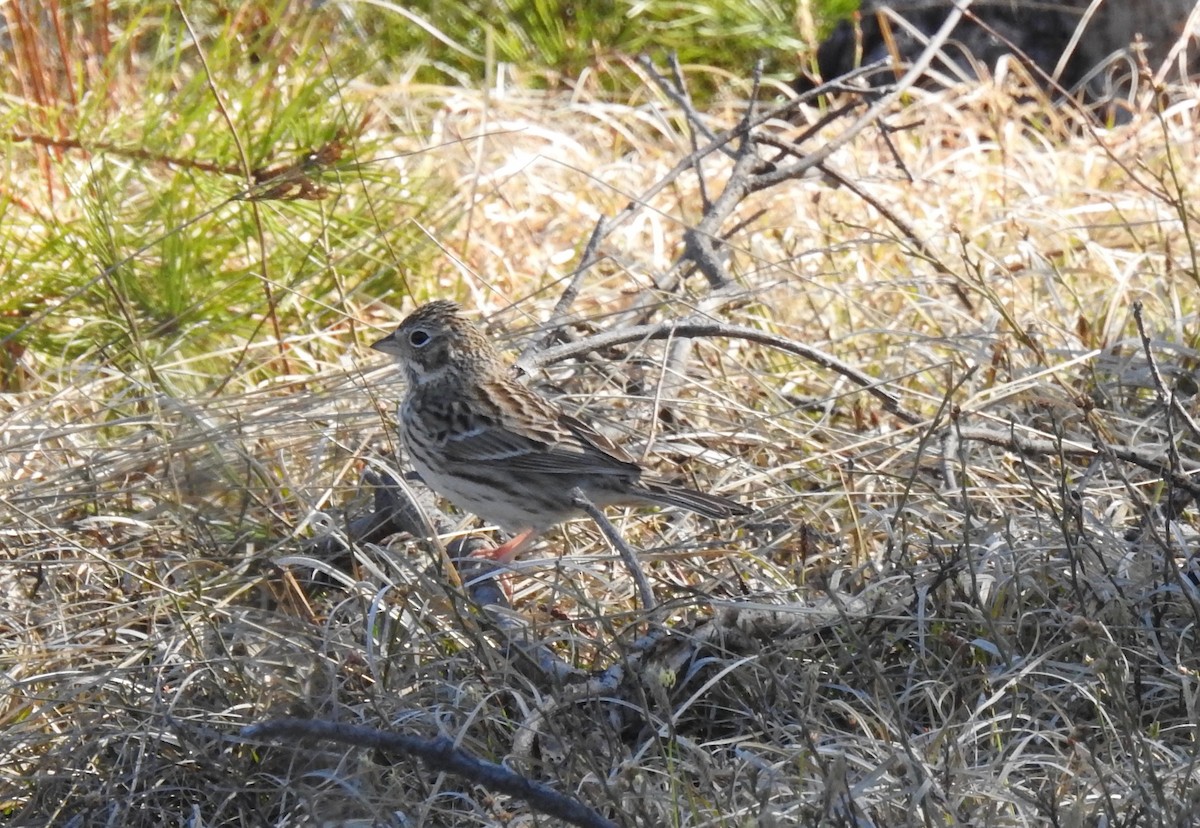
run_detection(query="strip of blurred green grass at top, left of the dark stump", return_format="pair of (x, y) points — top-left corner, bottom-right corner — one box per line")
(359, 0), (857, 91)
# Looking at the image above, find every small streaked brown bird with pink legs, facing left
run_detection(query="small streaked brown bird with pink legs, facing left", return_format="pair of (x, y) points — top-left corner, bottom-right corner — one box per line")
(371, 300), (750, 560)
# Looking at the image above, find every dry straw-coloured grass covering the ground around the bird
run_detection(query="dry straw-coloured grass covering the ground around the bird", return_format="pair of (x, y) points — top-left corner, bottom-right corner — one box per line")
(0, 59), (1200, 826)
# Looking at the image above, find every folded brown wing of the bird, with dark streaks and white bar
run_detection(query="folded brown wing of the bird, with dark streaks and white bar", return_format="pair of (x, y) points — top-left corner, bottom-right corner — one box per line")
(444, 383), (641, 478)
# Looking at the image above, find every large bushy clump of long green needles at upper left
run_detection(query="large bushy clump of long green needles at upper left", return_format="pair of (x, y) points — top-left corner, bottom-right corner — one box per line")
(0, 4), (455, 382)
